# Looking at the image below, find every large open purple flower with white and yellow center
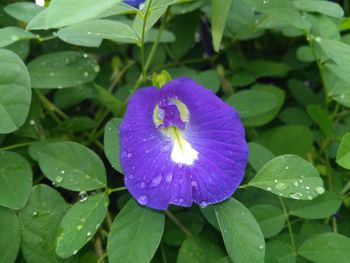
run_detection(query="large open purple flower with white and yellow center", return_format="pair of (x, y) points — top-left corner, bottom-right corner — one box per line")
(119, 77), (248, 210)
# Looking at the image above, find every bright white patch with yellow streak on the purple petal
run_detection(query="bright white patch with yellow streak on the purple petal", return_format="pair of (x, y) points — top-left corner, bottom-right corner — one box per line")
(171, 131), (198, 165)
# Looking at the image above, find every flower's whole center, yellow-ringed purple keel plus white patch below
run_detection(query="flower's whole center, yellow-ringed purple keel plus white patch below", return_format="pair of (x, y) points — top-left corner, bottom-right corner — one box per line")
(153, 99), (198, 165)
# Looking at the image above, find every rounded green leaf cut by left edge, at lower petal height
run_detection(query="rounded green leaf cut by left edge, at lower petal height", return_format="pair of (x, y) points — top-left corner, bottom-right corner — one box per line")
(0, 151), (33, 209)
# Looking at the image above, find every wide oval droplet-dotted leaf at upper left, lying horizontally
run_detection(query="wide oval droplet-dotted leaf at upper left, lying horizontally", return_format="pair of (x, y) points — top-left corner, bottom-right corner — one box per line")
(28, 51), (100, 89)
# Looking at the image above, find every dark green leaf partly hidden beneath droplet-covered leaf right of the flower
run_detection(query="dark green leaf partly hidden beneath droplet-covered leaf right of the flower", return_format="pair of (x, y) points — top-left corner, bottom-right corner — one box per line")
(289, 192), (342, 219)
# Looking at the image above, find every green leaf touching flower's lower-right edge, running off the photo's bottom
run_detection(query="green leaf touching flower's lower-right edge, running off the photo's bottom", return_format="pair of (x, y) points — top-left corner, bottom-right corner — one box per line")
(214, 198), (265, 263)
